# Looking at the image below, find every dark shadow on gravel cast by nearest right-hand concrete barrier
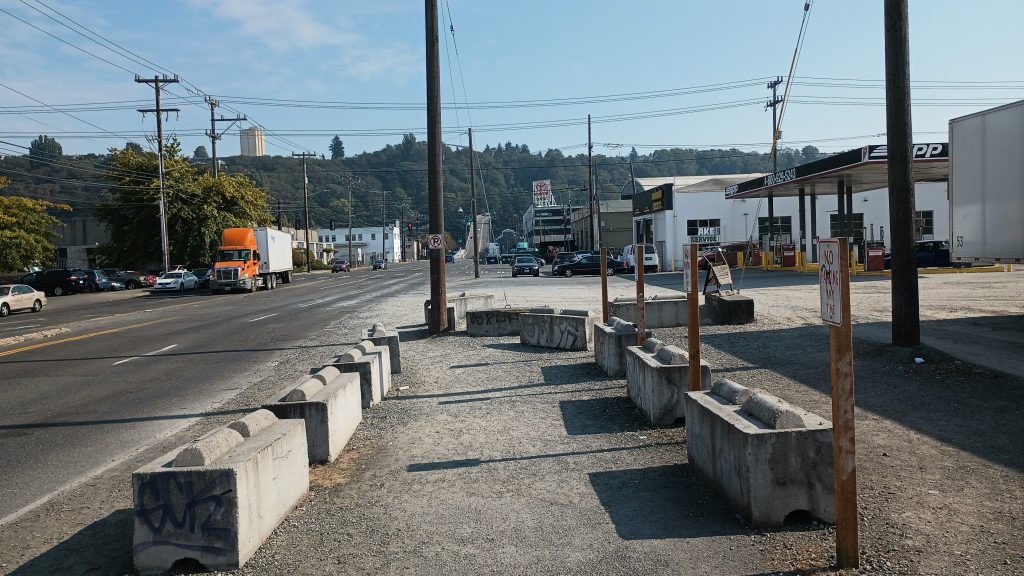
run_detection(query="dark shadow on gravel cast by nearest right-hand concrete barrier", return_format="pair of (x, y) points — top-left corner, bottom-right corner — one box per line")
(588, 464), (748, 540)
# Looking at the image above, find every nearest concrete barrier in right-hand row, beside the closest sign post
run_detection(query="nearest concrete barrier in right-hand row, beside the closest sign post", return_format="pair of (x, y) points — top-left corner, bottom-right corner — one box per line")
(686, 382), (836, 528)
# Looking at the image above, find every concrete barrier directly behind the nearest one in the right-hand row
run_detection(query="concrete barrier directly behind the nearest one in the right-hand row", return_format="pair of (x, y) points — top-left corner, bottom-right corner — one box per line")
(626, 338), (711, 426)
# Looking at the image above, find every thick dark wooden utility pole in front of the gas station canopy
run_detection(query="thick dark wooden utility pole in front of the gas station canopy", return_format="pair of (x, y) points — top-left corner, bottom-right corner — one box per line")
(885, 0), (921, 346)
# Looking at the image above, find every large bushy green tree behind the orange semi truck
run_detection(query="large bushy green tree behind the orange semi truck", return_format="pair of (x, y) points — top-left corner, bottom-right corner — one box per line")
(96, 139), (271, 266)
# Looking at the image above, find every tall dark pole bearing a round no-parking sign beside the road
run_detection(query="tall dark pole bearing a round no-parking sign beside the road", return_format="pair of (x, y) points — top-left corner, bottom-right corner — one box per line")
(424, 0), (449, 334)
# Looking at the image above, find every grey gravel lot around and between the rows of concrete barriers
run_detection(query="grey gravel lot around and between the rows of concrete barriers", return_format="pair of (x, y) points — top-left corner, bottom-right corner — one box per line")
(0, 262), (1024, 575)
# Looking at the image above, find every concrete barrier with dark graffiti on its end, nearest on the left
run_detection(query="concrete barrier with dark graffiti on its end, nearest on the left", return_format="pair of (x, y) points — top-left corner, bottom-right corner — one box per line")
(132, 410), (309, 574)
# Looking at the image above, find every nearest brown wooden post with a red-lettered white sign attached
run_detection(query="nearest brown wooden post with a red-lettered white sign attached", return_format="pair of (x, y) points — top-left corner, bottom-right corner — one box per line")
(818, 238), (860, 568)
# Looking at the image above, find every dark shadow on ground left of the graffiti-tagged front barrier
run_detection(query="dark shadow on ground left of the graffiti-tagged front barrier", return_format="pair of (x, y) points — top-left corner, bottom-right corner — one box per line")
(10, 508), (134, 576)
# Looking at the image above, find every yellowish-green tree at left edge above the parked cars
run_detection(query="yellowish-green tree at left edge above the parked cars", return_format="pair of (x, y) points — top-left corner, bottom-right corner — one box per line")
(0, 177), (71, 272)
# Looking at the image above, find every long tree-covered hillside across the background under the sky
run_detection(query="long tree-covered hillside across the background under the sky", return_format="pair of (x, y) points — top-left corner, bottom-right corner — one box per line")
(0, 134), (820, 238)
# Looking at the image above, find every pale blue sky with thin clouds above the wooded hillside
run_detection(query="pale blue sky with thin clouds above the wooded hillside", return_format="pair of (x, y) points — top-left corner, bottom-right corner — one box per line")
(0, 0), (1024, 156)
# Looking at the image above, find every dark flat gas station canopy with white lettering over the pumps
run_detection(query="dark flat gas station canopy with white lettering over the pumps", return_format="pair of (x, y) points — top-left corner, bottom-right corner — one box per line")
(725, 142), (949, 200)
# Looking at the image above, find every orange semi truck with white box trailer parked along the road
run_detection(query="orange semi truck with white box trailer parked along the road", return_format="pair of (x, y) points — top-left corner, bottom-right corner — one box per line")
(210, 228), (292, 294)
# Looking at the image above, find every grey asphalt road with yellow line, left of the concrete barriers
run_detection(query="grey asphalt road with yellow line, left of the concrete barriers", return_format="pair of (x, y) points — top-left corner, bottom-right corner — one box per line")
(0, 262), (432, 524)
